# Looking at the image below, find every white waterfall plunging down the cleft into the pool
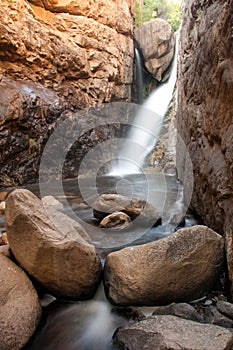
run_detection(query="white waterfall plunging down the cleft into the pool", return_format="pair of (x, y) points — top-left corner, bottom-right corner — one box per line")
(110, 39), (178, 176)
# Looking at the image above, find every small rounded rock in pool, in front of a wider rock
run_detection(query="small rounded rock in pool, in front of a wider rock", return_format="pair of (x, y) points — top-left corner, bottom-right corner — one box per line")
(99, 211), (131, 230)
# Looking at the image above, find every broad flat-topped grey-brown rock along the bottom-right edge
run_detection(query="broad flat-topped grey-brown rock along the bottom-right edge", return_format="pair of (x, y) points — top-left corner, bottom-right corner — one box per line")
(114, 316), (233, 350)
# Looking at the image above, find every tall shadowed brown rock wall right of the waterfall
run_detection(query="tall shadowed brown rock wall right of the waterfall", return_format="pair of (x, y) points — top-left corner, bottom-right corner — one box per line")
(177, 0), (233, 296)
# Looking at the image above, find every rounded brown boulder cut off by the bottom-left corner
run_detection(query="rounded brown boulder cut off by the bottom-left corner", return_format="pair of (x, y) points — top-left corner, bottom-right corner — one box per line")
(0, 254), (41, 350)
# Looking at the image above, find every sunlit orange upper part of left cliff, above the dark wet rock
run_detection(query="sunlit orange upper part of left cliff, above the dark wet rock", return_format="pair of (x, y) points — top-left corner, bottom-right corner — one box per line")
(0, 0), (133, 106)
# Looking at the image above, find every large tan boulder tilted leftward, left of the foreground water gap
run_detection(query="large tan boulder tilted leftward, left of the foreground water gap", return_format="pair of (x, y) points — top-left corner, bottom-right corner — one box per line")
(5, 190), (101, 299)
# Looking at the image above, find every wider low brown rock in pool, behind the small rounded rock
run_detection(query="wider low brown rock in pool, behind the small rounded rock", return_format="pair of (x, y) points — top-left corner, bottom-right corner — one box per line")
(93, 193), (161, 225)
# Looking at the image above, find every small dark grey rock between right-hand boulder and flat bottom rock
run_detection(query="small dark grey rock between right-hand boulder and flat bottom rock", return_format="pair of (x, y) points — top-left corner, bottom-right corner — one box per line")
(152, 303), (204, 322)
